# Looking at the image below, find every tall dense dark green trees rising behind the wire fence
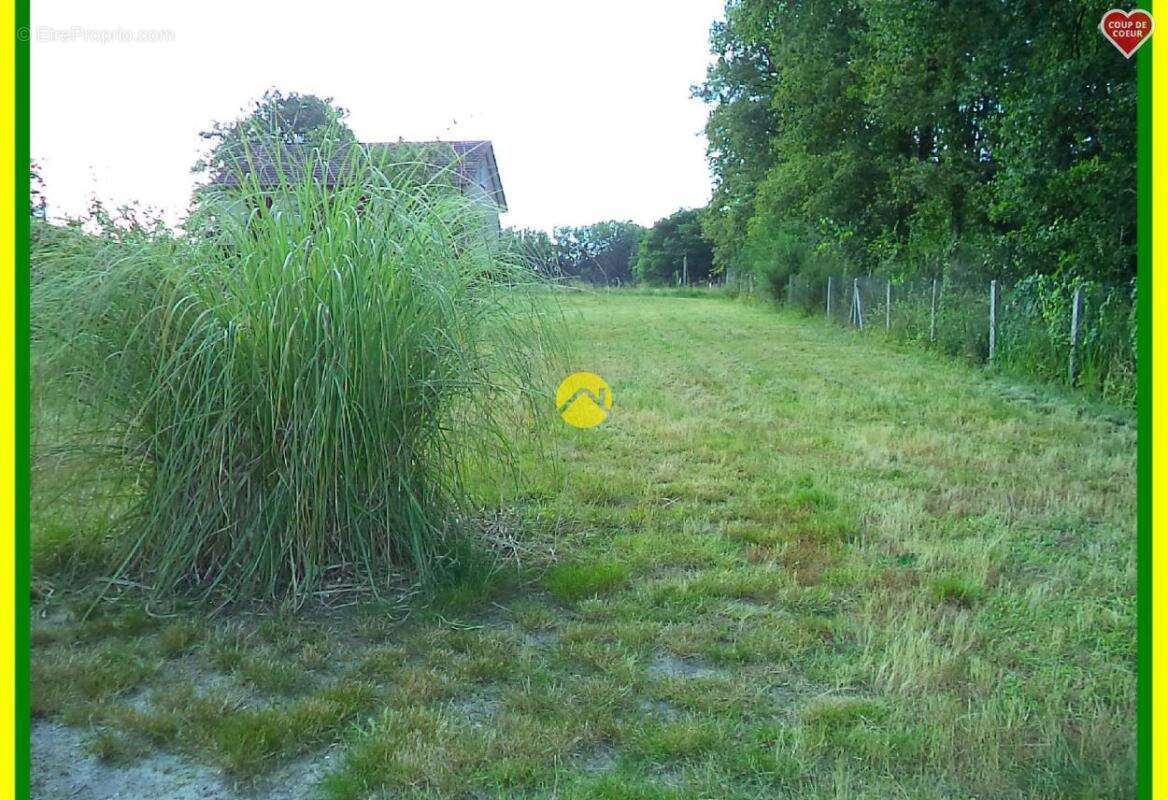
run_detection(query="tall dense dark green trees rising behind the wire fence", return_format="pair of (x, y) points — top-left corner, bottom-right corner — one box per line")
(695, 0), (1135, 285)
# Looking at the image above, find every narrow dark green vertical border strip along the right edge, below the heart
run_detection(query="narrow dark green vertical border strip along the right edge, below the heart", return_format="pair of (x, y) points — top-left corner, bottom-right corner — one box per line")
(1135, 32), (1155, 800)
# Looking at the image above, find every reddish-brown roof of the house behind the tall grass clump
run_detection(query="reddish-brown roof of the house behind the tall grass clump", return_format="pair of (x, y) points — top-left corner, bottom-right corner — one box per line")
(213, 139), (507, 211)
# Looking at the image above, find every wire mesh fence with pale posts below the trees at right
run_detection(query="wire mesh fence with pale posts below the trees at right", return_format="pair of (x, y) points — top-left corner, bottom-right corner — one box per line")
(780, 274), (1136, 405)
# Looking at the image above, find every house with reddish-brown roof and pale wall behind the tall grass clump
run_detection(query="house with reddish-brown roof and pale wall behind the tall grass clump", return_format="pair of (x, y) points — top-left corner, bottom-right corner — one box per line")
(211, 140), (507, 231)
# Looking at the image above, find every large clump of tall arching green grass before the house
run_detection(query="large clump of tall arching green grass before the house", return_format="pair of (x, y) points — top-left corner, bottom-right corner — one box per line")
(33, 144), (555, 604)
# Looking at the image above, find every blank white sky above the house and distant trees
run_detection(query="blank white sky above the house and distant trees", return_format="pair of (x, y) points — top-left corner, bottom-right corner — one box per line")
(30, 0), (722, 229)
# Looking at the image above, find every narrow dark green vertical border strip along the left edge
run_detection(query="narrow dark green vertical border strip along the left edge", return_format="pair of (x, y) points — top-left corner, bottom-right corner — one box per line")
(13, 0), (33, 798)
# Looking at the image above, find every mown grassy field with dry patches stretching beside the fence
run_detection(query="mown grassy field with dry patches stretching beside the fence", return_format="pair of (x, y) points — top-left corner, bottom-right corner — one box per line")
(33, 293), (1135, 800)
